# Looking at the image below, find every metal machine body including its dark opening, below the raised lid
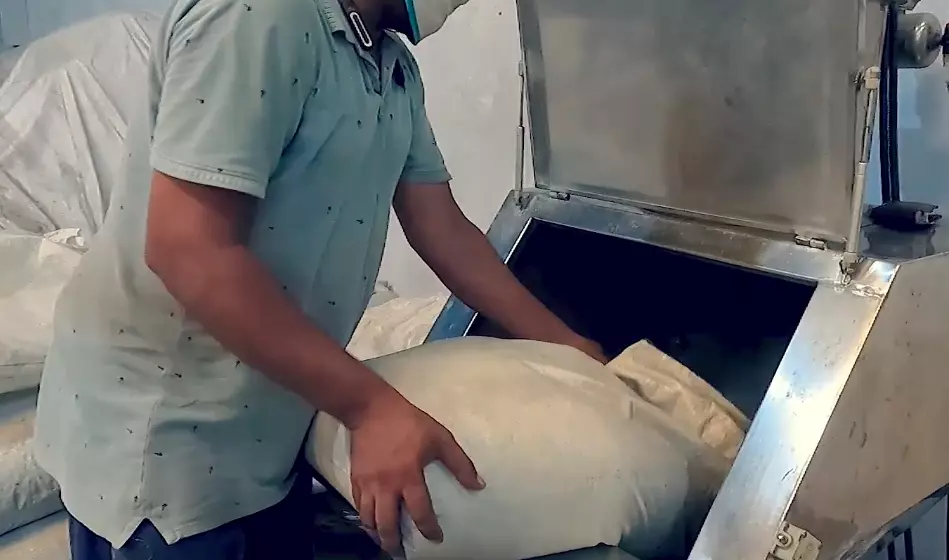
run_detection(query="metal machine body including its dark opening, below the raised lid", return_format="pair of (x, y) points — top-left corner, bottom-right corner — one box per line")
(429, 193), (949, 560)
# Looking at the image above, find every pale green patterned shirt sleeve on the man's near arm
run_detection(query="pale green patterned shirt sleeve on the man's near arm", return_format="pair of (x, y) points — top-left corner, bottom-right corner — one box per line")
(151, 0), (321, 198)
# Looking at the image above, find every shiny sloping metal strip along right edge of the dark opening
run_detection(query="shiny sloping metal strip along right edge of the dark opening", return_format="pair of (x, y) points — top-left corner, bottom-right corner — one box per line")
(689, 283), (882, 560)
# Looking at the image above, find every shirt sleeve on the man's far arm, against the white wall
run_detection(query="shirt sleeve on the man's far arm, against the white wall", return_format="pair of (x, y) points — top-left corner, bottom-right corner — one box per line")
(401, 65), (451, 185)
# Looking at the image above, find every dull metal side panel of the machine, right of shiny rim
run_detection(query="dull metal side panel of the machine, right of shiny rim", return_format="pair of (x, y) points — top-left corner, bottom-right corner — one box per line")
(788, 254), (949, 560)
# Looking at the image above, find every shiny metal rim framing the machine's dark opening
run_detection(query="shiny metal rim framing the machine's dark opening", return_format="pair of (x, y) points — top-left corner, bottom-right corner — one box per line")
(429, 191), (896, 560)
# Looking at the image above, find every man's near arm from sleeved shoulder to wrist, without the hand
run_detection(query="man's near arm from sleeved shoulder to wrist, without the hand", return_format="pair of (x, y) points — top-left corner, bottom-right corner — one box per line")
(145, 0), (392, 426)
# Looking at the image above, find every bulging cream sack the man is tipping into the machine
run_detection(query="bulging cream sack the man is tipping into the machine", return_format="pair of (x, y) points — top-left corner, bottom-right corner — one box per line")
(307, 337), (744, 560)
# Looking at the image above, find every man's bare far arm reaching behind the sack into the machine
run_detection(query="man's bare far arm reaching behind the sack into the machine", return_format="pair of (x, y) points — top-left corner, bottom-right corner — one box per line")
(394, 183), (606, 361)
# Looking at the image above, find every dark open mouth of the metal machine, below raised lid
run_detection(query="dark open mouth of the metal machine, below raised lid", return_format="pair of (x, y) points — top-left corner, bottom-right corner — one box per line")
(468, 220), (816, 418)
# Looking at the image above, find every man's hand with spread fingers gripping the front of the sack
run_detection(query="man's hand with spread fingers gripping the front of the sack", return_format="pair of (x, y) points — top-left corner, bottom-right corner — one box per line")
(350, 396), (484, 554)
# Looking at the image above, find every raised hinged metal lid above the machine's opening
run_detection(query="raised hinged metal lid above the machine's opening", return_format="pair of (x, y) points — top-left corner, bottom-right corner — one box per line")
(517, 0), (884, 241)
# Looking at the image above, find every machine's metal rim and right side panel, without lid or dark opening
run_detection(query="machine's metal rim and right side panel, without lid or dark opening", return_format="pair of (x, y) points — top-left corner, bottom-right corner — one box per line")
(429, 190), (949, 560)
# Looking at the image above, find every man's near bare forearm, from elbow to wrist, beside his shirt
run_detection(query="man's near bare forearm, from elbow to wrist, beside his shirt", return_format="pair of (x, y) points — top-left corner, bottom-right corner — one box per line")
(149, 245), (394, 428)
